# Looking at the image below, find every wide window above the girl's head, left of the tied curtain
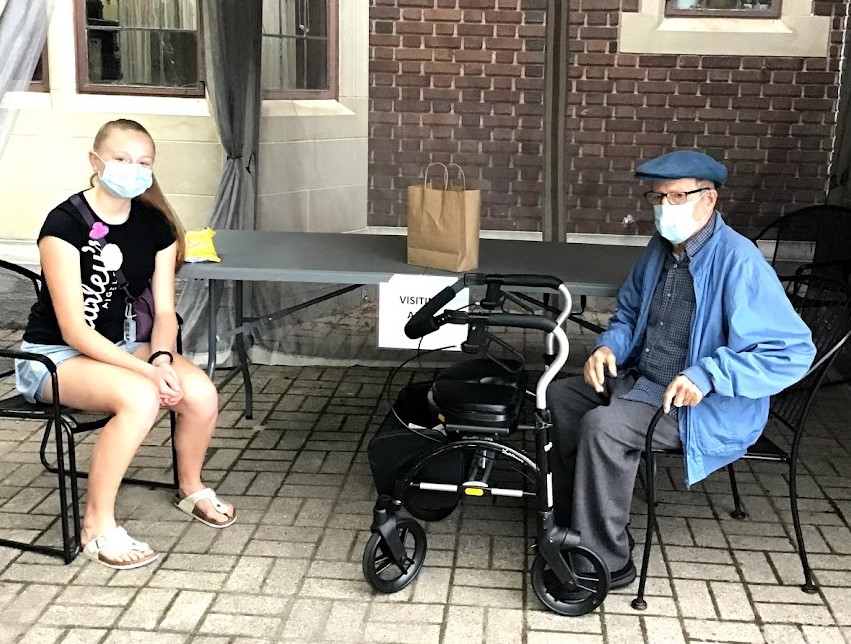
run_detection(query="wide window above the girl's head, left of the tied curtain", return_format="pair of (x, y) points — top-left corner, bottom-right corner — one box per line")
(77, 0), (204, 96)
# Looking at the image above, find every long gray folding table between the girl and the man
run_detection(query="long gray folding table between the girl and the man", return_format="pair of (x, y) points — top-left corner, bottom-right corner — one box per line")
(180, 230), (643, 418)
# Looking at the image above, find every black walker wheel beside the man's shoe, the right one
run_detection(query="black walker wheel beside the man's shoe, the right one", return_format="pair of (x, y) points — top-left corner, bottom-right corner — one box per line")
(531, 546), (610, 617)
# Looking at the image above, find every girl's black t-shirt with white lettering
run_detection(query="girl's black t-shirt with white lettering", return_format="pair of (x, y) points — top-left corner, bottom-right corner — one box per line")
(24, 193), (175, 344)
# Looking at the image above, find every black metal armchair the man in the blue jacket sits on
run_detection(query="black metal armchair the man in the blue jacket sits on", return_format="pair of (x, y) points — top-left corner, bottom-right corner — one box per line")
(632, 275), (851, 610)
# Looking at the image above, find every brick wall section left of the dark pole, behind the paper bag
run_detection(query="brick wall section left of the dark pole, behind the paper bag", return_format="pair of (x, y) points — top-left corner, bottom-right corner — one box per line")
(369, 0), (546, 230)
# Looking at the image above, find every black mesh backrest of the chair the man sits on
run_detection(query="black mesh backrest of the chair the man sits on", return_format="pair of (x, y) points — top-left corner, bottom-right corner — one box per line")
(771, 275), (851, 435)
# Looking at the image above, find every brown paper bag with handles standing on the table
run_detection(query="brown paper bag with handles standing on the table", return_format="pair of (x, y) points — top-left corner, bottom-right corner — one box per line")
(408, 163), (482, 273)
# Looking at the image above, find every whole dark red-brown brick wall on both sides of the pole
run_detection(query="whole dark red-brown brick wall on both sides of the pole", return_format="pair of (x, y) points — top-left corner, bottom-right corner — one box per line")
(369, 0), (845, 234)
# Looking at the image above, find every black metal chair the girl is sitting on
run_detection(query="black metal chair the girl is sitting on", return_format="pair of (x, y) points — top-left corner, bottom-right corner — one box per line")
(0, 260), (181, 564)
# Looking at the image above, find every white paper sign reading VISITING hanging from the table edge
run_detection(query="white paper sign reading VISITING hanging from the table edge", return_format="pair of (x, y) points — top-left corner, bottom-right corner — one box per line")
(378, 275), (470, 350)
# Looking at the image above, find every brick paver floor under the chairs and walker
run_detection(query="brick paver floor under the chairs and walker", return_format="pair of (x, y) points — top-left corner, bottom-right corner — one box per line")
(0, 332), (851, 644)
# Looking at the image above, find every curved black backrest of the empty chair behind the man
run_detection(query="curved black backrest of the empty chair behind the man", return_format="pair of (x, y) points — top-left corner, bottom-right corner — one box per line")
(752, 204), (851, 280)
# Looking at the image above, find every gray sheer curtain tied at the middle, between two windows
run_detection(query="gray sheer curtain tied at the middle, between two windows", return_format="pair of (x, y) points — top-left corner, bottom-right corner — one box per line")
(178, 0), (262, 360)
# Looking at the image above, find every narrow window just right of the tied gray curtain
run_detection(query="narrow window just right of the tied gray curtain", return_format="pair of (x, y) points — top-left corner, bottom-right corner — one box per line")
(260, 0), (337, 99)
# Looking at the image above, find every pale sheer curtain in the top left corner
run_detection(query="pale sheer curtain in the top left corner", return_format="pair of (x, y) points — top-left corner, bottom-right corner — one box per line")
(0, 0), (53, 155)
